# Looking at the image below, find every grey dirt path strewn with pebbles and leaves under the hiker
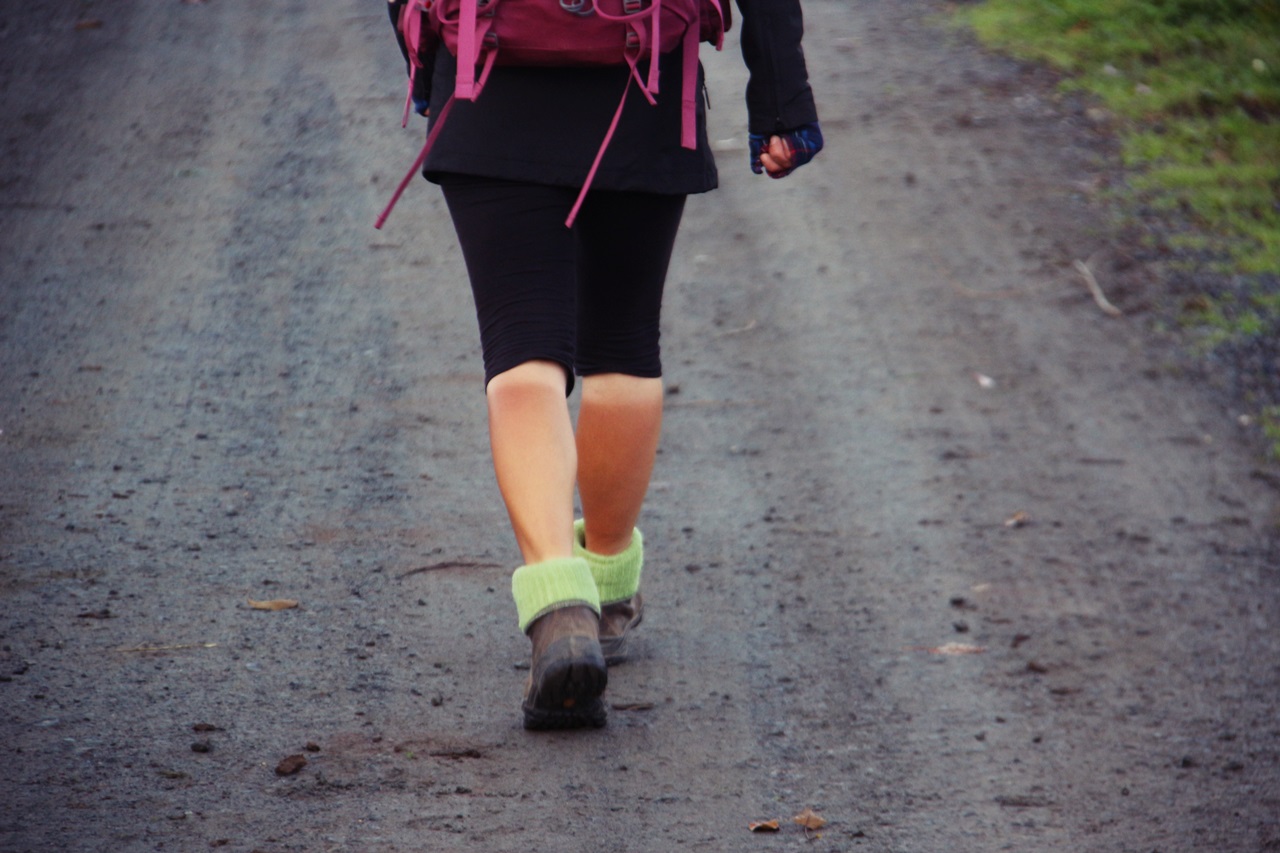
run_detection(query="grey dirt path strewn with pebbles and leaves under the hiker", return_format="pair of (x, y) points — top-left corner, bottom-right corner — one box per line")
(0, 0), (1280, 853)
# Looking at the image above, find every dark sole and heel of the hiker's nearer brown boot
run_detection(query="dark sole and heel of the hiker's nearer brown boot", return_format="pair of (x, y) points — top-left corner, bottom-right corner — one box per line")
(521, 637), (609, 731)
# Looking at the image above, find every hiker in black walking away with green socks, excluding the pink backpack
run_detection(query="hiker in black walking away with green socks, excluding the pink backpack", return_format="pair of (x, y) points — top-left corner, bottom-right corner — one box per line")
(392, 0), (822, 729)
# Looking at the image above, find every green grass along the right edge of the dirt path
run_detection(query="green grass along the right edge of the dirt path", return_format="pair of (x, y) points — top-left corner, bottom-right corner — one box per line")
(956, 0), (1280, 459)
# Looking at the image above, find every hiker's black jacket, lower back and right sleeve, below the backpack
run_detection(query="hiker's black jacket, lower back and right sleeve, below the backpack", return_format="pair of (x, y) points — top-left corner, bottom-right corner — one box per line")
(399, 0), (818, 193)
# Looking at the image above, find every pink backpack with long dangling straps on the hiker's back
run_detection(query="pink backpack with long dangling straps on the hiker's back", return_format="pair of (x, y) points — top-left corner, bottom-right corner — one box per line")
(375, 0), (731, 228)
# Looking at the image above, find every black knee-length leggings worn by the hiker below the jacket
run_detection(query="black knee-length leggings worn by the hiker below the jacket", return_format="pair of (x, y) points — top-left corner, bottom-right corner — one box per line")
(440, 175), (685, 391)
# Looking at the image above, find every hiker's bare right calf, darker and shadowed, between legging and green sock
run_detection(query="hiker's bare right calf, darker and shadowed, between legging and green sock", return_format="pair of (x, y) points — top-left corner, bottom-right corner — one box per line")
(577, 373), (663, 555)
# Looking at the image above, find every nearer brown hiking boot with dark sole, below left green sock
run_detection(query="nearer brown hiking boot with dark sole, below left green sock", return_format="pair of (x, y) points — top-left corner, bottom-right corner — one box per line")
(521, 606), (609, 731)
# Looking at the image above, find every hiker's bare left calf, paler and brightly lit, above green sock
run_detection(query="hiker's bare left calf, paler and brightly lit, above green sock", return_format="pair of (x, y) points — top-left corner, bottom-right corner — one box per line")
(486, 361), (577, 565)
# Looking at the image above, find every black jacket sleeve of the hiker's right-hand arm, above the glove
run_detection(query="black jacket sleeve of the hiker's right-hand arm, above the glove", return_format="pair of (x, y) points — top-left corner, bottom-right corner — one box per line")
(737, 0), (818, 136)
